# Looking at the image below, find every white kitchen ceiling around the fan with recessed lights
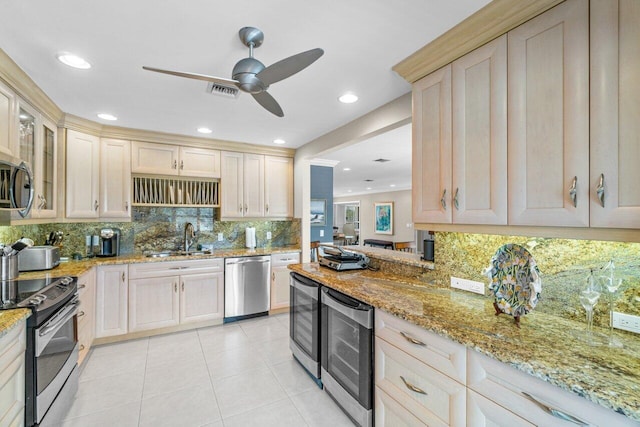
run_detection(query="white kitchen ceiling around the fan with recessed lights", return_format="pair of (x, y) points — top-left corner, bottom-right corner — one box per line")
(0, 0), (488, 150)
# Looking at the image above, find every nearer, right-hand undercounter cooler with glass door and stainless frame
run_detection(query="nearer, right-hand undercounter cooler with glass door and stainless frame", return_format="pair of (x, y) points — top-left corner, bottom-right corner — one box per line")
(320, 287), (373, 427)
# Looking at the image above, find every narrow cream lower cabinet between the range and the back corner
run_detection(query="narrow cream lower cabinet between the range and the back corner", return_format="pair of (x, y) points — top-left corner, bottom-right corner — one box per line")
(78, 268), (96, 365)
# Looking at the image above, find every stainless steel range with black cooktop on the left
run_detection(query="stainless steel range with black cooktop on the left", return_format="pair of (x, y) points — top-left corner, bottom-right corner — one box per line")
(0, 277), (79, 427)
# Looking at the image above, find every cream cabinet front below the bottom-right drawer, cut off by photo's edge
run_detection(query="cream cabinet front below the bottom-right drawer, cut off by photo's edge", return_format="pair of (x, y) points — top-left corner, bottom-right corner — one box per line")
(467, 390), (534, 427)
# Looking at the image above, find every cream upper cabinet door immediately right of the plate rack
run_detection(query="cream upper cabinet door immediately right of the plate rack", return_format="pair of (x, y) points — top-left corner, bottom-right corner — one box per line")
(220, 151), (244, 218)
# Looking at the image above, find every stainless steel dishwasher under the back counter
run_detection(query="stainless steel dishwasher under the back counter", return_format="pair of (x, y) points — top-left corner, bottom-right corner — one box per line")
(224, 255), (271, 322)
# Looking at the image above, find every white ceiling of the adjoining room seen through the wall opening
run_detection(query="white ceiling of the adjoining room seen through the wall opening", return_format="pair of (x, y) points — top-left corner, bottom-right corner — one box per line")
(314, 124), (411, 197)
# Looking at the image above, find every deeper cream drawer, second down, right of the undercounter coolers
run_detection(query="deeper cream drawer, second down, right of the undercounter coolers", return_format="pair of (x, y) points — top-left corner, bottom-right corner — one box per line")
(375, 339), (466, 426)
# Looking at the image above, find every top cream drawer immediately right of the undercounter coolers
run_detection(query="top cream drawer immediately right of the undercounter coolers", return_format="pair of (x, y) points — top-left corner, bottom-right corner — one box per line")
(375, 310), (467, 384)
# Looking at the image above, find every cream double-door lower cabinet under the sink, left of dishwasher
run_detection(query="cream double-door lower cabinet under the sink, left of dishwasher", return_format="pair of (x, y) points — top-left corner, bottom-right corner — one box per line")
(129, 259), (224, 332)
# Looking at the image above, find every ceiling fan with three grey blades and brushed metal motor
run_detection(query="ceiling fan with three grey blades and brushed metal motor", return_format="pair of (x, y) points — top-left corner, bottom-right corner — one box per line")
(142, 27), (324, 117)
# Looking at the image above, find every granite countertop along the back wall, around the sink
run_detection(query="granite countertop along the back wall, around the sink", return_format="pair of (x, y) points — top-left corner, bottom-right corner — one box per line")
(18, 246), (300, 279)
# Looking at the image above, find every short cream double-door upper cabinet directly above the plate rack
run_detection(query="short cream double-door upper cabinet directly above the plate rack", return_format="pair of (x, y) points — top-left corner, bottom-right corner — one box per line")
(131, 141), (220, 178)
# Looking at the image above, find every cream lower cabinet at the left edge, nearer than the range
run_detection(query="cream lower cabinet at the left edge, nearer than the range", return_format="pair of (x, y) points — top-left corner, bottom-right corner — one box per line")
(0, 320), (27, 427)
